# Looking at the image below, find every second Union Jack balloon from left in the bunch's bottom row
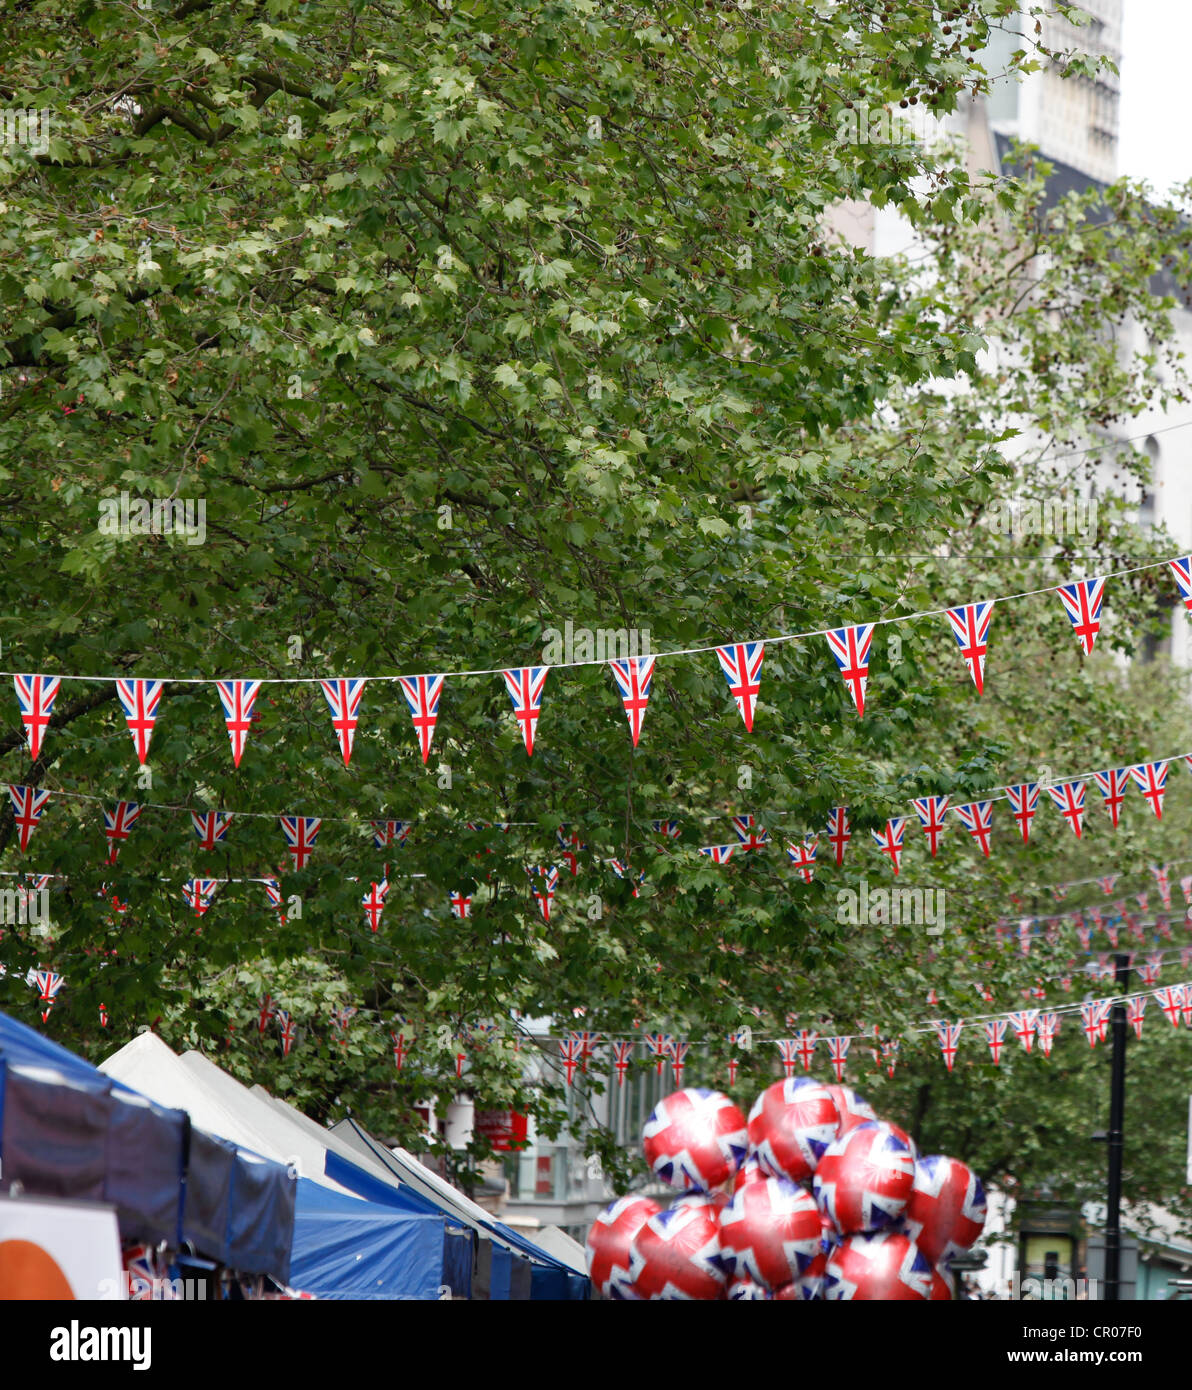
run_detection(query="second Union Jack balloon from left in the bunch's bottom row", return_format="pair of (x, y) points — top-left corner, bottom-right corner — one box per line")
(629, 1193), (727, 1301)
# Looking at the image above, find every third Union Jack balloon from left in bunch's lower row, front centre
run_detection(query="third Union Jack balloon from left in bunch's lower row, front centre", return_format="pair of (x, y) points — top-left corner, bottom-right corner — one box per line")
(720, 1177), (821, 1289)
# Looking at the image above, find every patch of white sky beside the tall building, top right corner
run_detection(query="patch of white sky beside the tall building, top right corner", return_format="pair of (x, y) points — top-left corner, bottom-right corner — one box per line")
(1117, 0), (1192, 192)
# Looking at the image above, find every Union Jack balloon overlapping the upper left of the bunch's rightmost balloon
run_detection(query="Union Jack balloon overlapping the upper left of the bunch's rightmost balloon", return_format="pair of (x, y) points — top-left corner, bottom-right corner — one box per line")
(814, 1122), (914, 1234)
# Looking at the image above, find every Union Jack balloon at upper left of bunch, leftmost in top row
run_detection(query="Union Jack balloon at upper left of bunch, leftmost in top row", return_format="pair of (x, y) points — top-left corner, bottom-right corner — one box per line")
(642, 1087), (749, 1191)
